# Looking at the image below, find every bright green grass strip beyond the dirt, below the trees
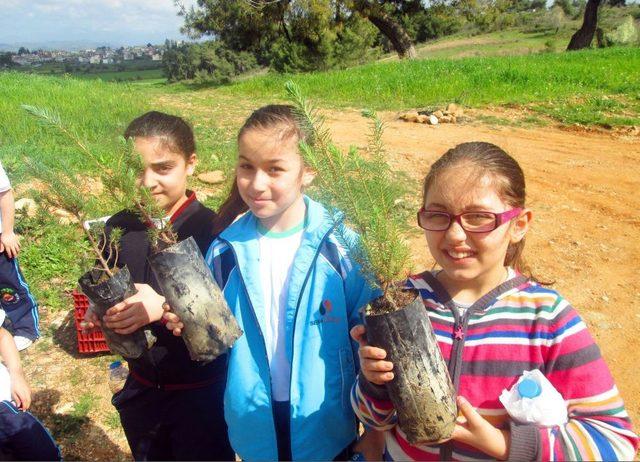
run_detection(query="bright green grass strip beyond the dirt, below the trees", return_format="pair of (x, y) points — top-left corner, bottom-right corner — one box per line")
(189, 48), (640, 125)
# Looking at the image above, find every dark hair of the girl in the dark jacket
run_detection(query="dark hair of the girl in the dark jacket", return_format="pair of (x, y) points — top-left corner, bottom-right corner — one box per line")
(124, 111), (196, 160)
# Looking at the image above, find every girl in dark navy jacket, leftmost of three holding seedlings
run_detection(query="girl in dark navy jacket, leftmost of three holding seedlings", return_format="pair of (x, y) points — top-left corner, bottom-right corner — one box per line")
(85, 111), (234, 460)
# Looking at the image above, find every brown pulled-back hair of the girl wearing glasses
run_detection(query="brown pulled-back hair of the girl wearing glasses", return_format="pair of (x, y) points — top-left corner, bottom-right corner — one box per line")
(422, 141), (533, 279)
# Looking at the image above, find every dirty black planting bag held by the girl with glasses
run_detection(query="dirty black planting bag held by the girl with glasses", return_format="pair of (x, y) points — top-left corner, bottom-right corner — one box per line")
(365, 297), (457, 444)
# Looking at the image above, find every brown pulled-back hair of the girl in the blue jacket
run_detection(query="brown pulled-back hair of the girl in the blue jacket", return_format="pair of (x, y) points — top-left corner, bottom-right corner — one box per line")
(214, 104), (309, 234)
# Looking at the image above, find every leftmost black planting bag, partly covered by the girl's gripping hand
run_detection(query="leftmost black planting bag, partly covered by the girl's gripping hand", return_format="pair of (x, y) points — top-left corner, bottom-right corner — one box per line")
(78, 266), (156, 359)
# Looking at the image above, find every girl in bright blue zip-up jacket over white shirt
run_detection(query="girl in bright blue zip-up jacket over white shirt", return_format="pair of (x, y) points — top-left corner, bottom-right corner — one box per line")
(165, 105), (380, 460)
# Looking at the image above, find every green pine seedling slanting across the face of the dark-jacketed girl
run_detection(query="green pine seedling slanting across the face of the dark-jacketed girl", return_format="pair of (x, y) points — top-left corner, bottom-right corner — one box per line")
(22, 104), (177, 251)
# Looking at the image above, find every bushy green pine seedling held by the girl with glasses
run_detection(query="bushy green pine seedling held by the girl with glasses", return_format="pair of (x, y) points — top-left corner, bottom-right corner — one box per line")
(286, 82), (410, 310)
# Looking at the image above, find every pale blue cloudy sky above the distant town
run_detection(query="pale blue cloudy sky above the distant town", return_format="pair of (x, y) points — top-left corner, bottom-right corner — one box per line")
(0, 0), (196, 46)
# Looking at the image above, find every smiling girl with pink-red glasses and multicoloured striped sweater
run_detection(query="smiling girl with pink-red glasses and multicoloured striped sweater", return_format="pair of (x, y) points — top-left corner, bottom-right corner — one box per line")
(351, 142), (638, 461)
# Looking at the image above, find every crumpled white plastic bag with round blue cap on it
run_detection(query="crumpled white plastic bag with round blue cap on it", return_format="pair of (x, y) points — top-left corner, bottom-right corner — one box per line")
(500, 369), (567, 427)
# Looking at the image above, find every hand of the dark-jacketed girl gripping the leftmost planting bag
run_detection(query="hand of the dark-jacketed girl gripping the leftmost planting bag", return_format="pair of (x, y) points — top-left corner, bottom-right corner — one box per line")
(103, 284), (164, 334)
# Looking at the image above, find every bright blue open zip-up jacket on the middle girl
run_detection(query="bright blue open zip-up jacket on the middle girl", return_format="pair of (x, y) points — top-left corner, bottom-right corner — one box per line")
(206, 197), (376, 460)
